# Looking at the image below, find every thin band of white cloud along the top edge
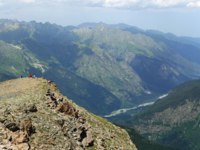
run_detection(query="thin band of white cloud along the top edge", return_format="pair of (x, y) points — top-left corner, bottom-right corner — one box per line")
(0, 0), (200, 9)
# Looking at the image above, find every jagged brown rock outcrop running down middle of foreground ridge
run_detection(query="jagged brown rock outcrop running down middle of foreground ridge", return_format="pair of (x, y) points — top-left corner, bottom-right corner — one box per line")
(46, 89), (94, 148)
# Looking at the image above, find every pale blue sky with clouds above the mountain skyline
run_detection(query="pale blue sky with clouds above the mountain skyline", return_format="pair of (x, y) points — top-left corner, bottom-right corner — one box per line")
(0, 0), (200, 37)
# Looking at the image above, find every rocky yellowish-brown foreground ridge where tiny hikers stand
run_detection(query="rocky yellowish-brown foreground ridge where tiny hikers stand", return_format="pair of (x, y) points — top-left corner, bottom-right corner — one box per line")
(0, 78), (136, 150)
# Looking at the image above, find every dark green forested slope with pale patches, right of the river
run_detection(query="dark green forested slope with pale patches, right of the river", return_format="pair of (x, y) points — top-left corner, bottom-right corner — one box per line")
(124, 80), (200, 150)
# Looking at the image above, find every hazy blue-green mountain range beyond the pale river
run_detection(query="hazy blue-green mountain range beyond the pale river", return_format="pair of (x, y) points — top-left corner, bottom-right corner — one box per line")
(0, 20), (200, 115)
